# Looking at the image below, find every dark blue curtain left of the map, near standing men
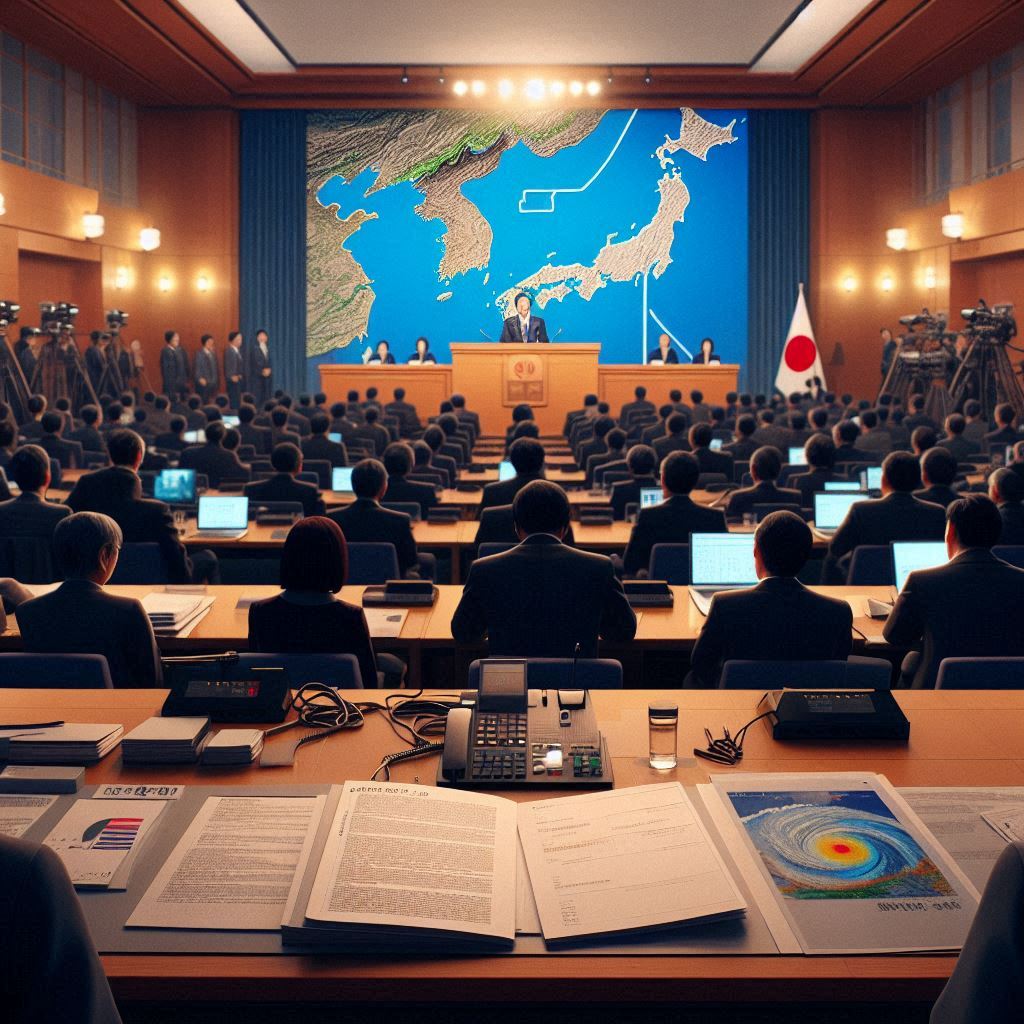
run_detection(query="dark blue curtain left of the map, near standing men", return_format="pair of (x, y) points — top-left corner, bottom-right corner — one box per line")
(239, 111), (306, 394)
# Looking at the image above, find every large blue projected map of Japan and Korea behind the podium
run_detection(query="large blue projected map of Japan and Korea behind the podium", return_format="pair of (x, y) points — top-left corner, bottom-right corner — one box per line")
(306, 108), (746, 361)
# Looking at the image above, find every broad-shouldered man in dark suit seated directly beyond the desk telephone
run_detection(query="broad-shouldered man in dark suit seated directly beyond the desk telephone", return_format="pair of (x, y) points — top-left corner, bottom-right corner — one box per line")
(452, 480), (637, 657)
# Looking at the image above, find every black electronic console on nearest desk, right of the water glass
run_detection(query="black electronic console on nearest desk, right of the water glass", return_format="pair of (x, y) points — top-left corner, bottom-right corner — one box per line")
(759, 689), (910, 740)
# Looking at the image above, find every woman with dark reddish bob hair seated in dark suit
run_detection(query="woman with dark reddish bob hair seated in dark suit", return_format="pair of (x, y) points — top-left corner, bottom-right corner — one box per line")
(249, 516), (377, 686)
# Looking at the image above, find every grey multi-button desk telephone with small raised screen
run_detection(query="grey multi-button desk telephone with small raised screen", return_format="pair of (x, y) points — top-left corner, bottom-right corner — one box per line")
(437, 659), (612, 790)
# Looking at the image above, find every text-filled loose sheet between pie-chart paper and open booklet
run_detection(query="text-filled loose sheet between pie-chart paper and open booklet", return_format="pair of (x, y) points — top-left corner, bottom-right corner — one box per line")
(125, 797), (325, 932)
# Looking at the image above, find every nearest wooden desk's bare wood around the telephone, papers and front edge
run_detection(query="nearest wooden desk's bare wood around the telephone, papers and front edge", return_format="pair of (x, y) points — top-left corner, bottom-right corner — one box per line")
(0, 689), (1024, 1020)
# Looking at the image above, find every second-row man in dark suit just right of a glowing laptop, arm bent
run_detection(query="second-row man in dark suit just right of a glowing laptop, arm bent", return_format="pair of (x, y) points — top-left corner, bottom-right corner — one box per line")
(822, 452), (945, 583)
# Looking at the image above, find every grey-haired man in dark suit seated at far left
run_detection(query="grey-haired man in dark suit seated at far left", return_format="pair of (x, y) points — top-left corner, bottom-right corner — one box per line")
(15, 512), (161, 687)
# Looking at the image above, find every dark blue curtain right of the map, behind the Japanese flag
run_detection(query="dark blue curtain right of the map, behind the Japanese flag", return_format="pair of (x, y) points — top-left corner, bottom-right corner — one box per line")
(744, 111), (814, 394)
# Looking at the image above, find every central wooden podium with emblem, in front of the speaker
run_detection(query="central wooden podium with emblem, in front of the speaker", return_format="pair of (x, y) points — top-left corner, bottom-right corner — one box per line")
(452, 341), (601, 434)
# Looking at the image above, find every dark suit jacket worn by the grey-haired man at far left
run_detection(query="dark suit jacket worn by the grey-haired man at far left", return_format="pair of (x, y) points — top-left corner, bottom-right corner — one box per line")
(15, 580), (162, 688)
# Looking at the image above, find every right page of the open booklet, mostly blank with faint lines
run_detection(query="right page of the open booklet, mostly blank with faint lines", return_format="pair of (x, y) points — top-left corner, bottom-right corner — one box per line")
(519, 782), (745, 940)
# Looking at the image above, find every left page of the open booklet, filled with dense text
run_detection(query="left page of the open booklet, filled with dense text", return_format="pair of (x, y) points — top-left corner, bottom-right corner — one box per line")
(306, 782), (516, 941)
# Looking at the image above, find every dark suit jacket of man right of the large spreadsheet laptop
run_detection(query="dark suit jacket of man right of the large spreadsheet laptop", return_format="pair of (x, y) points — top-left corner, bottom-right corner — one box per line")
(690, 573), (851, 686)
